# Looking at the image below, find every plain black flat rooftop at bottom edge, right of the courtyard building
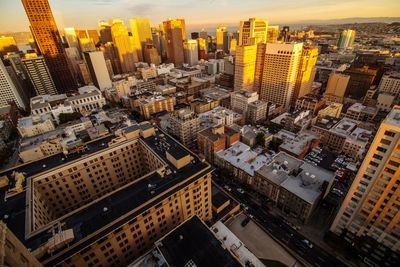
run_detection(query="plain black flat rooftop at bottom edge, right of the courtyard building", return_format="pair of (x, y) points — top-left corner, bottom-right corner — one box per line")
(156, 216), (242, 267)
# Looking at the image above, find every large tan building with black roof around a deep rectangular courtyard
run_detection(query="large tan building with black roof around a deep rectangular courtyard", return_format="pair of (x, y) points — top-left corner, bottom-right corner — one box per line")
(0, 122), (212, 266)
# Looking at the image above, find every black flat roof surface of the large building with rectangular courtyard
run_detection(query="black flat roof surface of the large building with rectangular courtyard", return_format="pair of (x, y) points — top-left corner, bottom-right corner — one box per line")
(0, 127), (211, 266)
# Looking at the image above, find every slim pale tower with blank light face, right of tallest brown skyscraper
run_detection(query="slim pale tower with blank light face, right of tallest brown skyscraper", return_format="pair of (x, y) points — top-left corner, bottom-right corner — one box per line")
(84, 51), (112, 91)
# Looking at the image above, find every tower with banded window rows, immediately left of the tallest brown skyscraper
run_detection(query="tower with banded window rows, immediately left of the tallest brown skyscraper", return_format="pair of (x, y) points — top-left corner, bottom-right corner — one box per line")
(22, 54), (58, 95)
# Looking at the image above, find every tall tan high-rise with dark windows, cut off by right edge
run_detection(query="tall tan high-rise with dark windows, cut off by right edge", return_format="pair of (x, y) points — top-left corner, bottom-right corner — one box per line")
(331, 106), (400, 266)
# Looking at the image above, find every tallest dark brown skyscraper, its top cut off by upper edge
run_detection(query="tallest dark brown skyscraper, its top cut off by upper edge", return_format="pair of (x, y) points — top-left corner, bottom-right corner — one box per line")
(22, 0), (77, 93)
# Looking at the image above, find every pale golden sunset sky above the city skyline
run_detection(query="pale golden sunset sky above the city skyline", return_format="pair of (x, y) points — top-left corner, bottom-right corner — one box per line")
(0, 0), (400, 32)
